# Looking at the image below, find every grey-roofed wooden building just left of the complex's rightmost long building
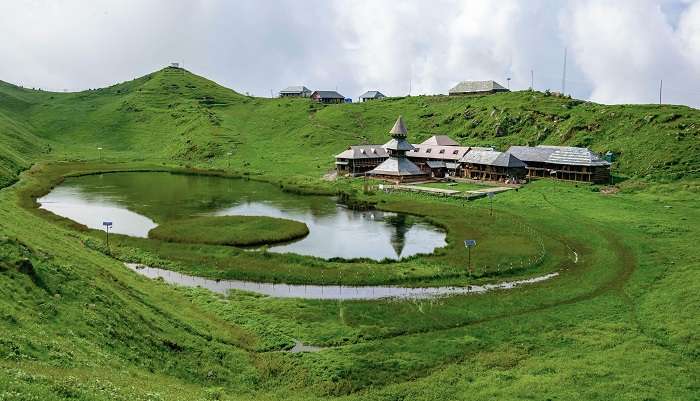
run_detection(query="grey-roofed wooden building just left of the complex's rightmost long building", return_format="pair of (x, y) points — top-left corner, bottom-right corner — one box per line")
(459, 149), (527, 181)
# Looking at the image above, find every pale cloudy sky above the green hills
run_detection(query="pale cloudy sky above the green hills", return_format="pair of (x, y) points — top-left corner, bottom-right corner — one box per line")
(0, 0), (700, 107)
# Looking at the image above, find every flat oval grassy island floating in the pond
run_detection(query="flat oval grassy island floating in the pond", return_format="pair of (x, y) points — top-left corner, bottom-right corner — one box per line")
(148, 216), (309, 246)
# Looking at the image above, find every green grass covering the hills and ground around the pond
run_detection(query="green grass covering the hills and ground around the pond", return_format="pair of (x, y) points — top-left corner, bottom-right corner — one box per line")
(0, 69), (700, 400)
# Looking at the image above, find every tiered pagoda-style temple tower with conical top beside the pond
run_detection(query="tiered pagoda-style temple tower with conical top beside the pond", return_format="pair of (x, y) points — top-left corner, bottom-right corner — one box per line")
(368, 116), (428, 182)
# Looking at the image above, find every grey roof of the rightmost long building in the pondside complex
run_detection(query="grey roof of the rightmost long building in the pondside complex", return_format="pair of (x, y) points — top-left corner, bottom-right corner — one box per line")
(508, 145), (610, 166)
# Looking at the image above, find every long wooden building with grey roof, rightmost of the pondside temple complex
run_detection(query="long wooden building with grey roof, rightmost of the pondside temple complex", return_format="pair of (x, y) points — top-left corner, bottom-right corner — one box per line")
(508, 145), (610, 184)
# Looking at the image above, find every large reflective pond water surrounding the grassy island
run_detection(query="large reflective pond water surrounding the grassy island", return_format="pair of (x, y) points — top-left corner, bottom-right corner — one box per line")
(38, 172), (446, 260)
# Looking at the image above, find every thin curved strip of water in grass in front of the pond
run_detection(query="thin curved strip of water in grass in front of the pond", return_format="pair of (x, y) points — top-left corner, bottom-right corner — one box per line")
(125, 263), (559, 300)
